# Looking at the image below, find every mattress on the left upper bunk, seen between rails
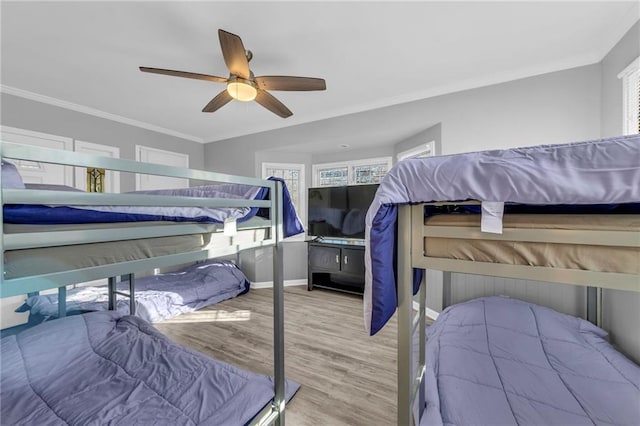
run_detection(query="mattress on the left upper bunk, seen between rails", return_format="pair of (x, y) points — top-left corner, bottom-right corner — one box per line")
(4, 217), (270, 279)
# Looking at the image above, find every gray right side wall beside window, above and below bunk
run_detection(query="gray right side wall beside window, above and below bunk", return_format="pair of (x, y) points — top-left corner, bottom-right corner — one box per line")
(601, 22), (640, 363)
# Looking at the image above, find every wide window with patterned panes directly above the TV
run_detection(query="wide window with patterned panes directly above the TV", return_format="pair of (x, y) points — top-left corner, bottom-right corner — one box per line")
(313, 157), (391, 186)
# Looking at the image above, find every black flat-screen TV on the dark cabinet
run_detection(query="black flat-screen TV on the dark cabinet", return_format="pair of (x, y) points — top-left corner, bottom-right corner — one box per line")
(307, 184), (378, 239)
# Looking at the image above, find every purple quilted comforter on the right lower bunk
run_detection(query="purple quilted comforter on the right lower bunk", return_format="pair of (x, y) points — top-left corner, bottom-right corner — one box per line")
(421, 297), (640, 426)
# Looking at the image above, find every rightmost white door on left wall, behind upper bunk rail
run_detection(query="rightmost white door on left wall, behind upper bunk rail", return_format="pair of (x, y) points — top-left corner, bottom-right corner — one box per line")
(136, 145), (189, 190)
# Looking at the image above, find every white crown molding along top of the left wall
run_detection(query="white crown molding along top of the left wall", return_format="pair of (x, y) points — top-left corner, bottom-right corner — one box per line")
(0, 84), (205, 144)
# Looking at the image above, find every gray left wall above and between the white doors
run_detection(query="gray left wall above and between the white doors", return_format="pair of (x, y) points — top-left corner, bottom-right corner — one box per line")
(0, 93), (204, 192)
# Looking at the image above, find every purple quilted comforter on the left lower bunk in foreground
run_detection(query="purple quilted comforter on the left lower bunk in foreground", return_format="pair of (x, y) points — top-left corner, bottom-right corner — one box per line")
(0, 312), (299, 425)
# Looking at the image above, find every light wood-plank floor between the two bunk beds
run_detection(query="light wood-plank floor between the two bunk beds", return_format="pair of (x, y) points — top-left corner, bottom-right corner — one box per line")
(155, 286), (396, 426)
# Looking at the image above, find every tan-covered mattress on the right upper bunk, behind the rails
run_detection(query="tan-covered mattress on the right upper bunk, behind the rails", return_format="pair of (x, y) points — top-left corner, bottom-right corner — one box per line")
(424, 214), (640, 274)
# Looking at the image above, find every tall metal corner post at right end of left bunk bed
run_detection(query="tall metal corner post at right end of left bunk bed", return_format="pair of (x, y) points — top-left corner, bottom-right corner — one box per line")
(272, 182), (285, 426)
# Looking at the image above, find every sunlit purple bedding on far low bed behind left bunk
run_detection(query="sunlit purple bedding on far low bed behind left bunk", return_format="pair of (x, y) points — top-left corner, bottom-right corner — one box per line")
(17, 260), (250, 322)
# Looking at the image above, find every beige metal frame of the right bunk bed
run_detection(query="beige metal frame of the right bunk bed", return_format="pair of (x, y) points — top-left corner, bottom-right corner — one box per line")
(397, 202), (640, 426)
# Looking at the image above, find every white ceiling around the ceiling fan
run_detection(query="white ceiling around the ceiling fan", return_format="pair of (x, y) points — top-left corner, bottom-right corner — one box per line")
(1, 1), (640, 147)
